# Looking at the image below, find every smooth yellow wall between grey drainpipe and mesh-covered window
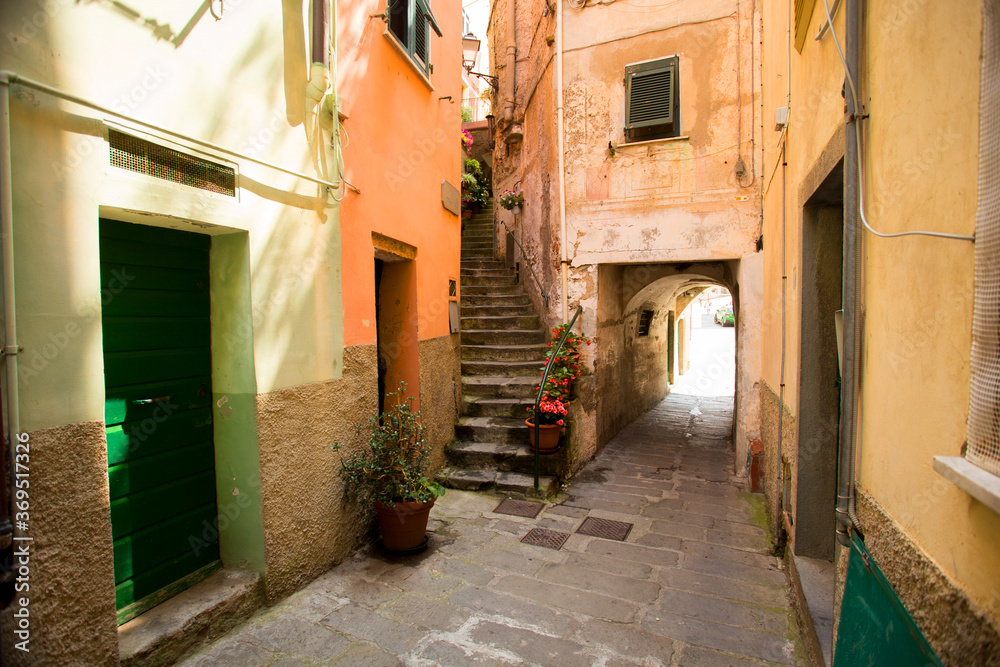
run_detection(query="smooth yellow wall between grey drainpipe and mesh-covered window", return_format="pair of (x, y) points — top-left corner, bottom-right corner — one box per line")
(859, 0), (1000, 621)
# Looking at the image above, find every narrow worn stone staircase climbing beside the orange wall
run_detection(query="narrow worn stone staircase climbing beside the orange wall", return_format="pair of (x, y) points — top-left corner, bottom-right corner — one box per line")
(439, 205), (565, 497)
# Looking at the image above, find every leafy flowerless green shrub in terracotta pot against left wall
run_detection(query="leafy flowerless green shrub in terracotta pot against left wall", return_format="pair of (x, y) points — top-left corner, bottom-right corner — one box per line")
(333, 382), (444, 553)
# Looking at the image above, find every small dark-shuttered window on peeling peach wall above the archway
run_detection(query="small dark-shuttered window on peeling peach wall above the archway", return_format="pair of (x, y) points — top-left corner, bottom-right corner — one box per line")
(625, 56), (681, 141)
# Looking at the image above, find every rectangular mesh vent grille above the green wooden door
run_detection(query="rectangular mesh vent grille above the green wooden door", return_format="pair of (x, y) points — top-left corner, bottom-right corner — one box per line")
(108, 130), (236, 197)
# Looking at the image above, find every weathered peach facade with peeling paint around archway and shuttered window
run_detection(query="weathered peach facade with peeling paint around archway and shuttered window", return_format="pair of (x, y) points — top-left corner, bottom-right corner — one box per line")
(488, 0), (762, 470)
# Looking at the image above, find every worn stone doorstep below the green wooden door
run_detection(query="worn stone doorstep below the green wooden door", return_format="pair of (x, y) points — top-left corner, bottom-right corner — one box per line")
(118, 569), (264, 667)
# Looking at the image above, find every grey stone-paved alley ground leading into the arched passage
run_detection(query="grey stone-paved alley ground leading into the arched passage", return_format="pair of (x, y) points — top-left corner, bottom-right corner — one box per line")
(183, 395), (805, 667)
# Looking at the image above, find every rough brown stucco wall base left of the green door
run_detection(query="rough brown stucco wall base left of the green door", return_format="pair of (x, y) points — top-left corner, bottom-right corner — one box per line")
(0, 421), (118, 665)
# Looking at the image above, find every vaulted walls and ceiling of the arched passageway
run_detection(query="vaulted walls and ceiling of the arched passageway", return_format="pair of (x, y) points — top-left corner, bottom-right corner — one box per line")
(595, 260), (760, 472)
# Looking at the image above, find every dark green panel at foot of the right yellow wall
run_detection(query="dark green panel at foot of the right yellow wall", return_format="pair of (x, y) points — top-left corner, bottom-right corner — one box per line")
(834, 535), (941, 667)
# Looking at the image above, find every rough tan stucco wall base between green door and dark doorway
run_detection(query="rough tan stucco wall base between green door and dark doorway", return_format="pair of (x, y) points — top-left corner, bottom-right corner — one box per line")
(257, 345), (378, 602)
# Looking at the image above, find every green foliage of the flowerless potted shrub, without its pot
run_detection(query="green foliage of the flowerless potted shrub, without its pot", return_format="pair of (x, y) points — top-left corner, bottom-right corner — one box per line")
(333, 382), (444, 506)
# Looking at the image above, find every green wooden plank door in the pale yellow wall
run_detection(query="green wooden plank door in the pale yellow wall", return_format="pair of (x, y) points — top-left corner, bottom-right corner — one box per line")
(100, 219), (219, 623)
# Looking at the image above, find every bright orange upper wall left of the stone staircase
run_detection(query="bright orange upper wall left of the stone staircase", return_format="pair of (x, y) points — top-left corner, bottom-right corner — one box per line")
(336, 0), (462, 366)
